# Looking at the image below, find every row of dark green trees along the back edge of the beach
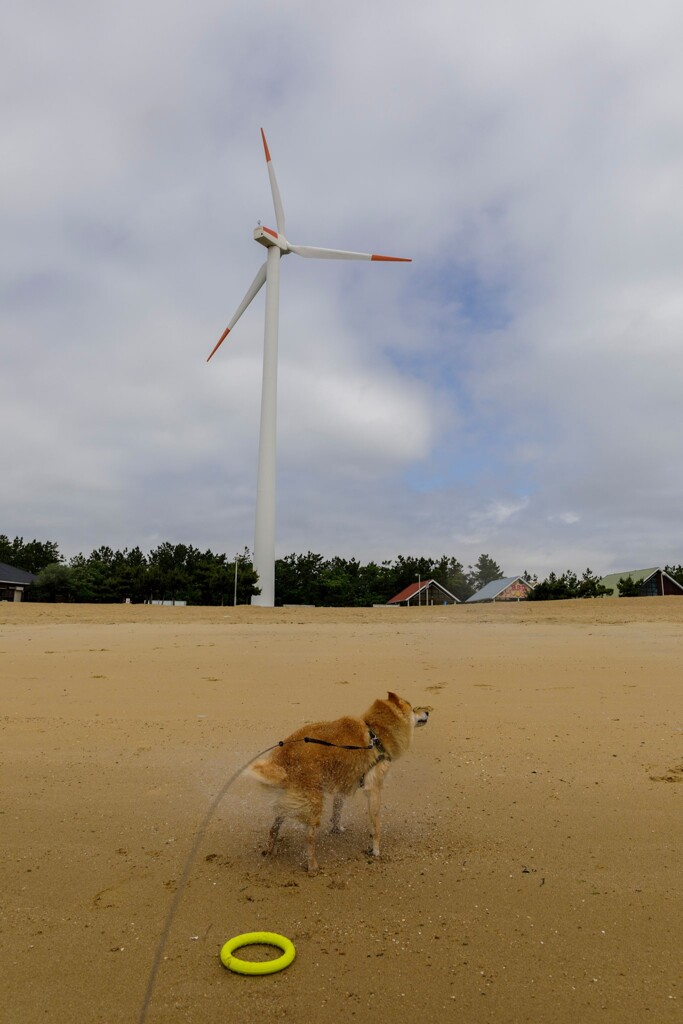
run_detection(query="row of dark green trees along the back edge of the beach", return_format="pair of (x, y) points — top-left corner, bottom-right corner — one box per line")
(0, 535), (683, 607)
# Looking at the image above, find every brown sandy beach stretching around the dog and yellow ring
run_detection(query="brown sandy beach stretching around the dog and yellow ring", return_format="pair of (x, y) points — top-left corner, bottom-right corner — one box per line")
(0, 598), (683, 1024)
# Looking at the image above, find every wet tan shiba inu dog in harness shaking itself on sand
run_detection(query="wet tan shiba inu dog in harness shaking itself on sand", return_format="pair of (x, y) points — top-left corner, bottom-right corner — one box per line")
(248, 692), (429, 874)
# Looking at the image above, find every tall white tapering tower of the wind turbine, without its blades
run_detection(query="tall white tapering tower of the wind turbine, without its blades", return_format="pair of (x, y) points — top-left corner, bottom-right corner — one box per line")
(252, 246), (280, 608)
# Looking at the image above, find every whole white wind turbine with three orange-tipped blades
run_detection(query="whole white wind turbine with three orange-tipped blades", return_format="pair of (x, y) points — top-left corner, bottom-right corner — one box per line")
(207, 128), (412, 608)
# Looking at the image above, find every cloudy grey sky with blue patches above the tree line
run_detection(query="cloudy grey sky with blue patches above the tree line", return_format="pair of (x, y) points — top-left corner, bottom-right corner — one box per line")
(0, 0), (683, 575)
